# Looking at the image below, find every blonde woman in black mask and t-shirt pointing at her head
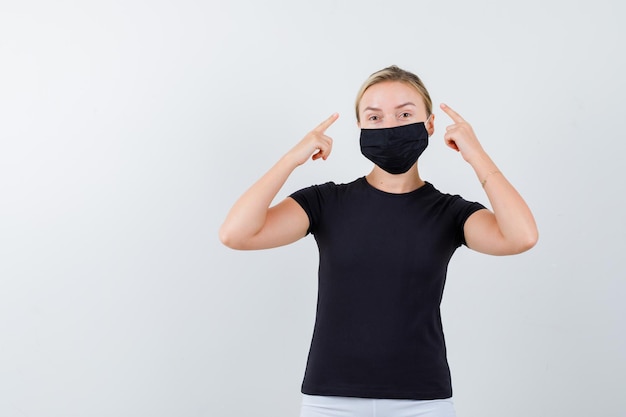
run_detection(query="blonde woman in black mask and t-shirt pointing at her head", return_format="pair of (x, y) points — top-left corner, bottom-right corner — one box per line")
(220, 66), (538, 417)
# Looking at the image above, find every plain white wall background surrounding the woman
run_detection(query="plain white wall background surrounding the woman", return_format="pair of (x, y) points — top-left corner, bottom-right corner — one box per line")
(0, 0), (626, 417)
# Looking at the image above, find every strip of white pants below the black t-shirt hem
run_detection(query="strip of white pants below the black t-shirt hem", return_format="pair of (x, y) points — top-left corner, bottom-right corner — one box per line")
(300, 394), (456, 417)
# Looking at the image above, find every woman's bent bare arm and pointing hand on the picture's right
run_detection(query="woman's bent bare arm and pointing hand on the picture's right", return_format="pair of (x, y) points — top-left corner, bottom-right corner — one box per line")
(441, 104), (538, 255)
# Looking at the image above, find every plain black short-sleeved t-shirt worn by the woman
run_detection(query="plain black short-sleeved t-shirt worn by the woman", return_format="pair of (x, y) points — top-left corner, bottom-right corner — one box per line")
(291, 177), (484, 400)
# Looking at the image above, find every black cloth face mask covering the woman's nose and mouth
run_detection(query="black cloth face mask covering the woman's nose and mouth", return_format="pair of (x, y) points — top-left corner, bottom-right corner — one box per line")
(361, 122), (428, 174)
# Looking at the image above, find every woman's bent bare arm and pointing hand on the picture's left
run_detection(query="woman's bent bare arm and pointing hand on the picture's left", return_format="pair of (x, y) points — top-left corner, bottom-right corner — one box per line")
(219, 113), (339, 249)
